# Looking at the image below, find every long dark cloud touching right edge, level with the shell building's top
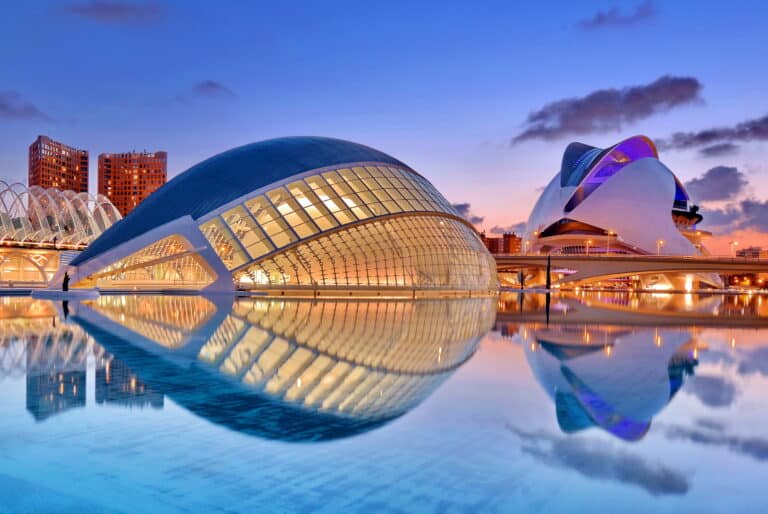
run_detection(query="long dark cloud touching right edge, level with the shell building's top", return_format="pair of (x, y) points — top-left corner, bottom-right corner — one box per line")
(657, 115), (768, 150)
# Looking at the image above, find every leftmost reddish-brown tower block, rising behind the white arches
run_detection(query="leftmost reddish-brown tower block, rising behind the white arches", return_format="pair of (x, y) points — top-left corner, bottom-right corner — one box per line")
(28, 136), (88, 193)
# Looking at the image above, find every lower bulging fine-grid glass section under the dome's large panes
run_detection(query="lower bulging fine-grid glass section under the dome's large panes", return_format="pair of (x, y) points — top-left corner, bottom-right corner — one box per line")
(234, 215), (496, 289)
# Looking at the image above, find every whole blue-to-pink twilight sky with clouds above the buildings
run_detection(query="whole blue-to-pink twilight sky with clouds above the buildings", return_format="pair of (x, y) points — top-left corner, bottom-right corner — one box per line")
(0, 0), (768, 253)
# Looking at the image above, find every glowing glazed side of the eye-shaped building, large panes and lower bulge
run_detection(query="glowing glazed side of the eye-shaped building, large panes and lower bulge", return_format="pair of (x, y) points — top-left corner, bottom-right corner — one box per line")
(200, 166), (496, 290)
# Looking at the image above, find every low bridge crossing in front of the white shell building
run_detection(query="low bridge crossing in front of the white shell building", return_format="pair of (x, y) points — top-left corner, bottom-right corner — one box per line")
(495, 255), (768, 285)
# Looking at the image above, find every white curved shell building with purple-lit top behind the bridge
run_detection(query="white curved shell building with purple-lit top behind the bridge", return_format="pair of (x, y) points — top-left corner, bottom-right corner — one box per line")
(523, 136), (706, 255)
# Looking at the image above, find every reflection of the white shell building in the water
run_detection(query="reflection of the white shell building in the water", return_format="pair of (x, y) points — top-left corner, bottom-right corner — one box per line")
(519, 324), (704, 441)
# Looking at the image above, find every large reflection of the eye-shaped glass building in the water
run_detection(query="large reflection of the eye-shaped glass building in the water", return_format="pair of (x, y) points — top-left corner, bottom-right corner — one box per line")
(71, 295), (495, 441)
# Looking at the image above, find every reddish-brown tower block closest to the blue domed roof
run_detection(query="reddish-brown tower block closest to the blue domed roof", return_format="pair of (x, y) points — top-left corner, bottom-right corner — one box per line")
(99, 152), (168, 216)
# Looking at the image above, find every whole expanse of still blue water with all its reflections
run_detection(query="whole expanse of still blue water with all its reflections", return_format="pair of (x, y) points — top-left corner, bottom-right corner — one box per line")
(0, 292), (768, 513)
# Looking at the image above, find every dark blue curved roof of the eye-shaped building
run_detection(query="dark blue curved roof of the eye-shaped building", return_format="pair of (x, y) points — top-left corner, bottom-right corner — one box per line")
(72, 136), (413, 265)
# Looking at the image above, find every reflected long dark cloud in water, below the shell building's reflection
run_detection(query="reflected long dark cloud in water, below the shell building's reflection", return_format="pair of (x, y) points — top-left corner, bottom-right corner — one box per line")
(507, 424), (690, 496)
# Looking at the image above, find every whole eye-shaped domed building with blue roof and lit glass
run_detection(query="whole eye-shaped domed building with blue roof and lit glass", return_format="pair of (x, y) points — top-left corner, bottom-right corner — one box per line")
(69, 137), (497, 292)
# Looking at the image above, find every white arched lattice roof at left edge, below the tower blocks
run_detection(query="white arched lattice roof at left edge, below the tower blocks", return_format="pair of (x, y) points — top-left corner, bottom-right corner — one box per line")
(0, 181), (121, 249)
